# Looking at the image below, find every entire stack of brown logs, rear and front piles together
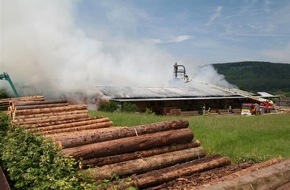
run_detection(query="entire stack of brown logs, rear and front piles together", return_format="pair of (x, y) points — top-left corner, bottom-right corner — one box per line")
(9, 97), (230, 189)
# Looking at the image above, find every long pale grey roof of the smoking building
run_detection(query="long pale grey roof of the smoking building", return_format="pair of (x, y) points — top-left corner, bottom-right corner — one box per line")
(97, 83), (251, 101)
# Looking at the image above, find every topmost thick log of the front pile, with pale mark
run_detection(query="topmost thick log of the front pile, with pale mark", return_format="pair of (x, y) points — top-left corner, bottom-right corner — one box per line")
(57, 120), (188, 148)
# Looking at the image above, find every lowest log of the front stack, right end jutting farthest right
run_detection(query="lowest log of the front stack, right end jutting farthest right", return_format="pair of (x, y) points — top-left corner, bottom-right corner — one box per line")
(113, 157), (231, 189)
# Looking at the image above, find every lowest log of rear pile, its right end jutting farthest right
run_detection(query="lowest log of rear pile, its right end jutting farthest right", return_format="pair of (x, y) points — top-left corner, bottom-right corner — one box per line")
(29, 121), (113, 135)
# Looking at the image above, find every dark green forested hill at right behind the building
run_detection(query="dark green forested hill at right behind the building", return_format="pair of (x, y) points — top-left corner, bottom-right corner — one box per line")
(212, 61), (290, 95)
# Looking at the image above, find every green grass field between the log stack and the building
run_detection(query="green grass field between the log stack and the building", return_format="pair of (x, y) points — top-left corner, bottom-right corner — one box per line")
(90, 112), (290, 162)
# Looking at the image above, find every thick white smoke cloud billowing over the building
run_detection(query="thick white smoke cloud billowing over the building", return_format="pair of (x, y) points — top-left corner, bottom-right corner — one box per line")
(0, 0), (231, 96)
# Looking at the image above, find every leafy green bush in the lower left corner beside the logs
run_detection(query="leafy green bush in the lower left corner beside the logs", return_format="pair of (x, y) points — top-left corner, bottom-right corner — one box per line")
(0, 113), (95, 190)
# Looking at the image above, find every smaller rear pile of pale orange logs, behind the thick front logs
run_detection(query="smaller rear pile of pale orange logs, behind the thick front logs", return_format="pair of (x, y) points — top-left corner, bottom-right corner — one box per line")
(8, 98), (113, 135)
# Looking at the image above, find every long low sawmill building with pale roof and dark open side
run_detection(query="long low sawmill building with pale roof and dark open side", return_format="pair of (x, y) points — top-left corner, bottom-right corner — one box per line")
(97, 83), (260, 115)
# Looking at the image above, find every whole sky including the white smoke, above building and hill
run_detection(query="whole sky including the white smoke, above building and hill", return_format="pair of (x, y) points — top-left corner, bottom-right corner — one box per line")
(0, 0), (290, 96)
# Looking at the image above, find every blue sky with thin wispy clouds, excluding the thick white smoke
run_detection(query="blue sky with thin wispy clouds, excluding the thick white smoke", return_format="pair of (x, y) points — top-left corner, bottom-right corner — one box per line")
(76, 0), (290, 64)
